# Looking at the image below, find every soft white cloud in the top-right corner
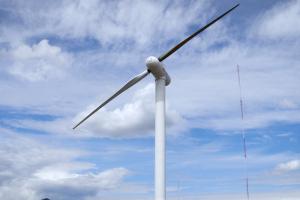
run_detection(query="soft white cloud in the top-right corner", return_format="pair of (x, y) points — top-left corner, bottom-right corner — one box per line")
(254, 0), (300, 39)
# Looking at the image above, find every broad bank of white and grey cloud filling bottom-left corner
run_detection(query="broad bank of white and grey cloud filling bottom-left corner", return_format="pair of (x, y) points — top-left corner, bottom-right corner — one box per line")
(0, 129), (129, 200)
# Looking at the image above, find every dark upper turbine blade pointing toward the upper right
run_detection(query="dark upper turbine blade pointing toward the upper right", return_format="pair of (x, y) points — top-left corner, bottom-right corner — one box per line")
(158, 4), (240, 62)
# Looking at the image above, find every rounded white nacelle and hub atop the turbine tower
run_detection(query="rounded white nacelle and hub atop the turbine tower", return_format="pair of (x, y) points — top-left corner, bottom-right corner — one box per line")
(146, 56), (171, 85)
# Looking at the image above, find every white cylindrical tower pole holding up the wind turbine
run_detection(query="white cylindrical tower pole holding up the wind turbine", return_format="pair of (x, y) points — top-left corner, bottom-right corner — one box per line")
(155, 78), (166, 200)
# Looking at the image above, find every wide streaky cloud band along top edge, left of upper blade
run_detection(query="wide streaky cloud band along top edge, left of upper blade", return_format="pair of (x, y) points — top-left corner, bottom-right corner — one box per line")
(1, 0), (208, 48)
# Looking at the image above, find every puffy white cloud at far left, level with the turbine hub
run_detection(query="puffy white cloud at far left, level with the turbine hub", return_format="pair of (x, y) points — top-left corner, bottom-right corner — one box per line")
(2, 40), (72, 81)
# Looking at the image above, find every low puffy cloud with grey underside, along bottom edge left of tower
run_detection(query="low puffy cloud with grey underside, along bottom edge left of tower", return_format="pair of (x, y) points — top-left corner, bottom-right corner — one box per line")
(33, 168), (128, 199)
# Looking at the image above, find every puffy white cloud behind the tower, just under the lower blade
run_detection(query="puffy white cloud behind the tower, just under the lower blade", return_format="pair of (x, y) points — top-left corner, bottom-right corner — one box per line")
(74, 84), (185, 138)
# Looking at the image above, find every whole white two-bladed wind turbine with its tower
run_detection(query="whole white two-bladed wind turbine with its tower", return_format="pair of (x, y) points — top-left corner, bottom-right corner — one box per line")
(73, 4), (239, 200)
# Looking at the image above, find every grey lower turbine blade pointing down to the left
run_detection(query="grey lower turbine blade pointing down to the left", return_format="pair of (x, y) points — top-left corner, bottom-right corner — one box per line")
(73, 70), (150, 129)
